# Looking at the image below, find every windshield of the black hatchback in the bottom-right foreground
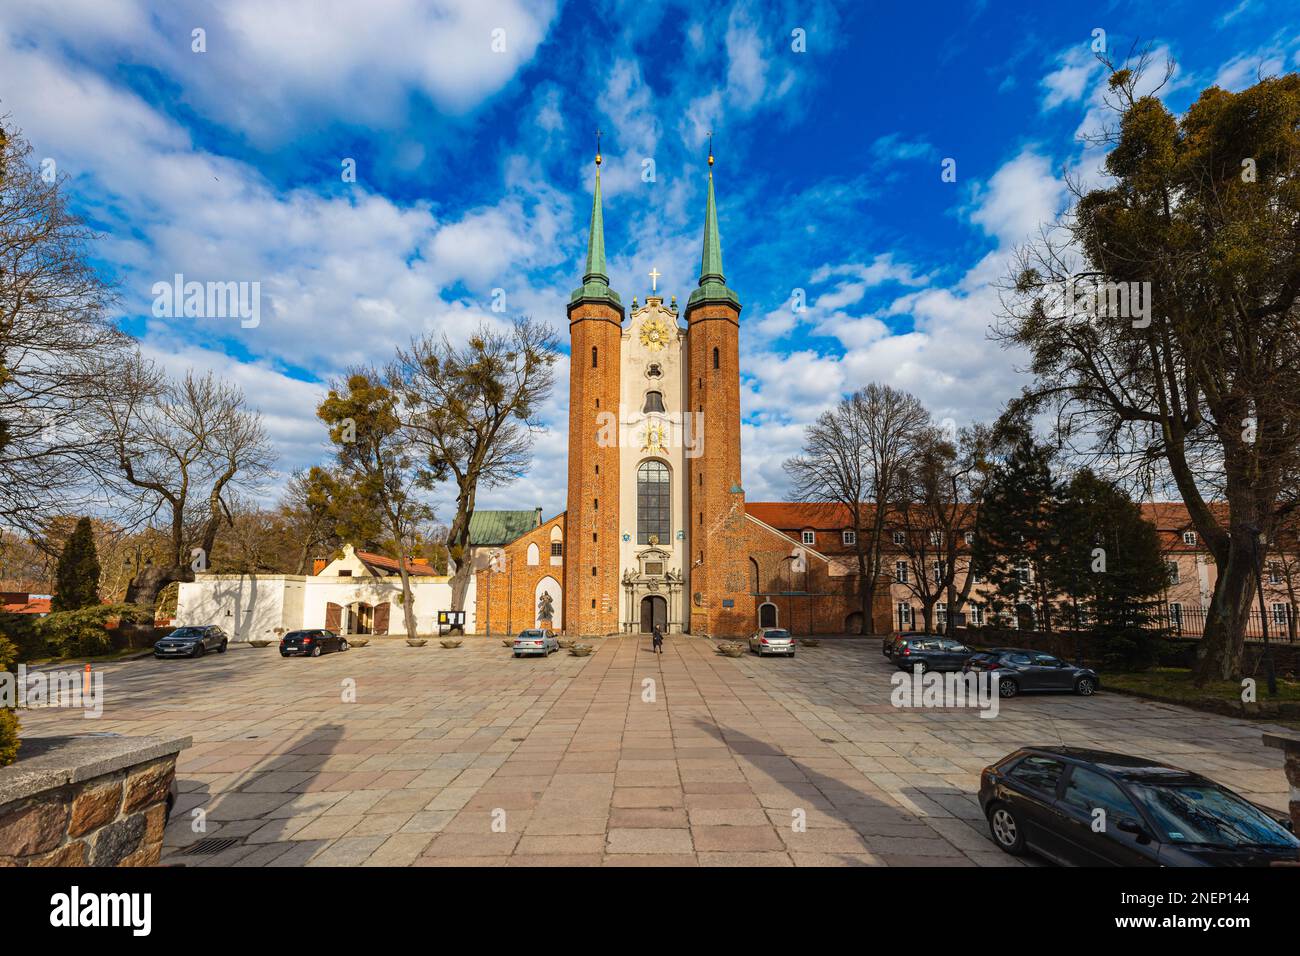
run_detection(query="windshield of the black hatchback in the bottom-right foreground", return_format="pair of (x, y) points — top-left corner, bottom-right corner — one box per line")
(1132, 783), (1300, 847)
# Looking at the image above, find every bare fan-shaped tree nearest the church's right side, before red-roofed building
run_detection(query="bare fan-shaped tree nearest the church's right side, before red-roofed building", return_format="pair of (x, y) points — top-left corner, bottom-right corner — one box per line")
(785, 382), (930, 633)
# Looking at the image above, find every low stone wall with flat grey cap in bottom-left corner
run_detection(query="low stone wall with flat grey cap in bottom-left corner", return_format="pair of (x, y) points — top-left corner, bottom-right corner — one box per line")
(0, 736), (190, 866)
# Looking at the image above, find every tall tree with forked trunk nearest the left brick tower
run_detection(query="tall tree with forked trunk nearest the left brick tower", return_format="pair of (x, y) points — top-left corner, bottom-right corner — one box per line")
(390, 317), (558, 610)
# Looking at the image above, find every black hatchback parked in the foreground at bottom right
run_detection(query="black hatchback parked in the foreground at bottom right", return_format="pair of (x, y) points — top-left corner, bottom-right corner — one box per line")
(979, 747), (1300, 866)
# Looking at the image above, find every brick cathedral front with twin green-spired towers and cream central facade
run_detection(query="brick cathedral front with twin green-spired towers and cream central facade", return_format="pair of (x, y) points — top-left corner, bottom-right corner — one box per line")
(476, 156), (878, 636)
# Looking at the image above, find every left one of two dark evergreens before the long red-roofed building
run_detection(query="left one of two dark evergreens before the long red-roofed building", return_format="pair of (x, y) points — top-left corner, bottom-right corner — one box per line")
(971, 421), (1054, 631)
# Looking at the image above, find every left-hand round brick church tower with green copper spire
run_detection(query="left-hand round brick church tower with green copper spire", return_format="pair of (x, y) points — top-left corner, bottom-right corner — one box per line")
(564, 150), (623, 635)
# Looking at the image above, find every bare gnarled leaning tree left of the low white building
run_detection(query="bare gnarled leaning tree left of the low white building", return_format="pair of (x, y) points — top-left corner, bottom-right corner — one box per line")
(99, 355), (273, 606)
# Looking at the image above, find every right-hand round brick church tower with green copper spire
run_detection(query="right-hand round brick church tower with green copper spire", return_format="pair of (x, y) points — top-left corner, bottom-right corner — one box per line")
(686, 148), (754, 636)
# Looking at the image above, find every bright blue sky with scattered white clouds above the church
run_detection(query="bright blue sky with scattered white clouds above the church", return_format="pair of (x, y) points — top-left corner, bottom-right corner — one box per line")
(0, 0), (1300, 512)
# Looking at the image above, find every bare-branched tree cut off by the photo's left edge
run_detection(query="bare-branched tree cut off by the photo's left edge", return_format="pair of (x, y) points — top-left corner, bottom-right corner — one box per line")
(0, 129), (131, 546)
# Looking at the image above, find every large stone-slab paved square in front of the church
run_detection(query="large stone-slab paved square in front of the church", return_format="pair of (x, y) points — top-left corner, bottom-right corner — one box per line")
(23, 636), (1287, 866)
